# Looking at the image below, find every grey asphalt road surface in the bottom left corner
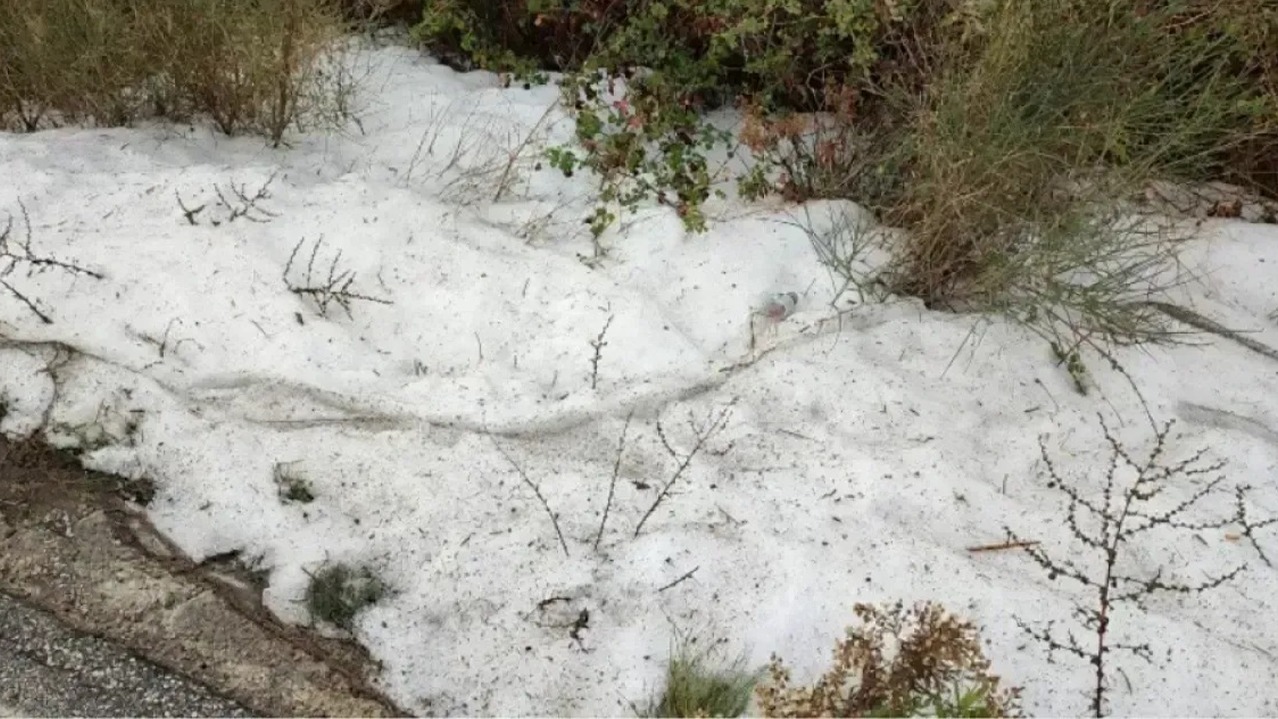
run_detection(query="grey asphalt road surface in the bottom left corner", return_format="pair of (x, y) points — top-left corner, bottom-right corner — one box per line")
(0, 593), (253, 716)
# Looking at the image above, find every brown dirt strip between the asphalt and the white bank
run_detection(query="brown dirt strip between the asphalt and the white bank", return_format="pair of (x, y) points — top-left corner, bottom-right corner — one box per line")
(0, 437), (404, 716)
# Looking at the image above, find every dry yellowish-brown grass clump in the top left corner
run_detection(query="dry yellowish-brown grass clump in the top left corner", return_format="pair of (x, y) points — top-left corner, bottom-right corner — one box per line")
(0, 0), (351, 144)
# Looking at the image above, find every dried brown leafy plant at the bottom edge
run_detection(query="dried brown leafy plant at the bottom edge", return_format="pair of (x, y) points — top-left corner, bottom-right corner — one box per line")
(755, 602), (1021, 716)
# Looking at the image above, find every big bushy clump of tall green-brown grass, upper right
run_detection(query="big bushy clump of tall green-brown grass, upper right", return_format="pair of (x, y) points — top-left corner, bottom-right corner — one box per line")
(828, 0), (1259, 346)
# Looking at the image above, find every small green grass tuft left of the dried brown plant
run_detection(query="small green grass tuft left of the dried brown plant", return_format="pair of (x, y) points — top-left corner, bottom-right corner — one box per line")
(643, 637), (759, 716)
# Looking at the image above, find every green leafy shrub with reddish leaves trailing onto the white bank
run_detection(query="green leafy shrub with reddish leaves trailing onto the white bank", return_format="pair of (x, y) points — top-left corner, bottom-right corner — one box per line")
(417, 0), (964, 235)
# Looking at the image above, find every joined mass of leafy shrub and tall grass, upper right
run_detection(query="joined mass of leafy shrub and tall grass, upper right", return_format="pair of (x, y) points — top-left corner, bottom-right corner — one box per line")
(415, 0), (1278, 354)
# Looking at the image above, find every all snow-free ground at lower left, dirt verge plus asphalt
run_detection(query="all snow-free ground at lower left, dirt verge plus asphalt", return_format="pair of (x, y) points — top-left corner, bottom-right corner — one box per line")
(0, 437), (403, 716)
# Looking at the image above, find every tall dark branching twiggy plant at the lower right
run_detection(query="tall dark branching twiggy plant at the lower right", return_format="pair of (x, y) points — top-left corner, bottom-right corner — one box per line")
(1007, 416), (1274, 716)
